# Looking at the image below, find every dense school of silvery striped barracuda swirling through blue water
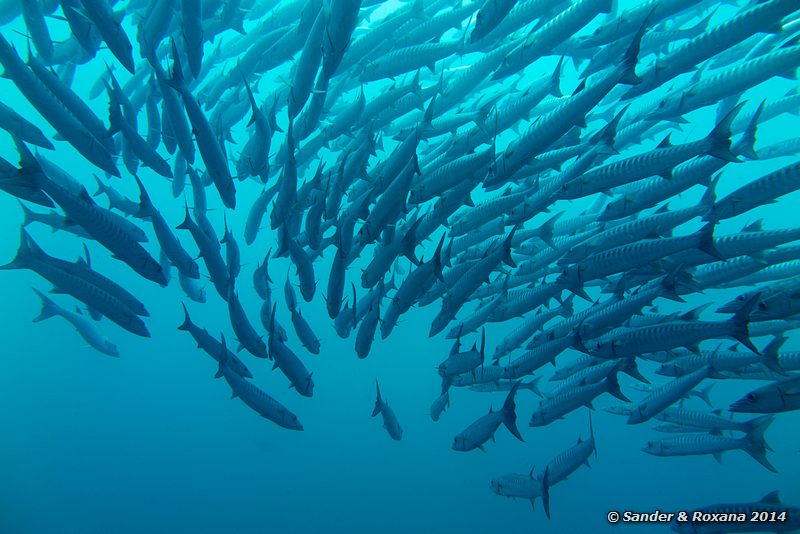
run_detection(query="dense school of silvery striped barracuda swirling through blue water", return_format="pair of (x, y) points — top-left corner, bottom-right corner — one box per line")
(0, 0), (800, 532)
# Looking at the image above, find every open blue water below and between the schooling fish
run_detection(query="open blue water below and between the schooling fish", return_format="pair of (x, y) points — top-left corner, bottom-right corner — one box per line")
(0, 0), (800, 534)
